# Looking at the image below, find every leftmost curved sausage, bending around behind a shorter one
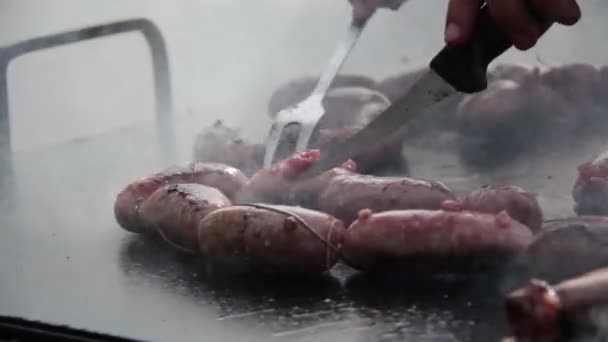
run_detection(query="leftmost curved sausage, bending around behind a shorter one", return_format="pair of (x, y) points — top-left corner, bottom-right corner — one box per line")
(114, 162), (247, 233)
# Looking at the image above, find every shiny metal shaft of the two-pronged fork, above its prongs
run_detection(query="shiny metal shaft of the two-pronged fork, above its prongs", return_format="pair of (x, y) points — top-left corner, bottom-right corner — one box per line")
(312, 18), (369, 99)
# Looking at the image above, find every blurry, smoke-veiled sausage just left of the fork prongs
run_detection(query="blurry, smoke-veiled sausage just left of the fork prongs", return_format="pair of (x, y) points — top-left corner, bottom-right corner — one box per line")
(192, 120), (265, 175)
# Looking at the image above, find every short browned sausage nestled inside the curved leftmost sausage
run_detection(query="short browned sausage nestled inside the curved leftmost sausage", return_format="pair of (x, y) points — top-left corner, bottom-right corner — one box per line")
(139, 184), (232, 252)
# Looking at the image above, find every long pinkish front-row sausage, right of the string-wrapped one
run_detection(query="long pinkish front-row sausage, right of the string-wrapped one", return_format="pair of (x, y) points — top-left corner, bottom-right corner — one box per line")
(341, 206), (533, 272)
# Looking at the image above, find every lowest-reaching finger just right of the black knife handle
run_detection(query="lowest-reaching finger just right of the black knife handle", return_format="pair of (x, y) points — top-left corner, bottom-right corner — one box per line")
(488, 0), (544, 50)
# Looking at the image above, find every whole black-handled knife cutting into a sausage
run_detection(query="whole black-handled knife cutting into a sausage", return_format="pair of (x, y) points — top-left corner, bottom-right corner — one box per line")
(298, 3), (513, 178)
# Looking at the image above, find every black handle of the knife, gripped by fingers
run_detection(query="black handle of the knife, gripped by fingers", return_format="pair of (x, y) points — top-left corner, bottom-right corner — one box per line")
(430, 4), (513, 94)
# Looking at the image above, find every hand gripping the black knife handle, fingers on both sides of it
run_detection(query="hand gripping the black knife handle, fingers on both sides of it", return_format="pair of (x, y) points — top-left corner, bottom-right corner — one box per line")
(445, 0), (581, 50)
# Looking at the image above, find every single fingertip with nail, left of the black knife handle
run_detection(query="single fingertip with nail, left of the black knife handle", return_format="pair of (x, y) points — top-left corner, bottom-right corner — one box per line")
(445, 0), (480, 45)
